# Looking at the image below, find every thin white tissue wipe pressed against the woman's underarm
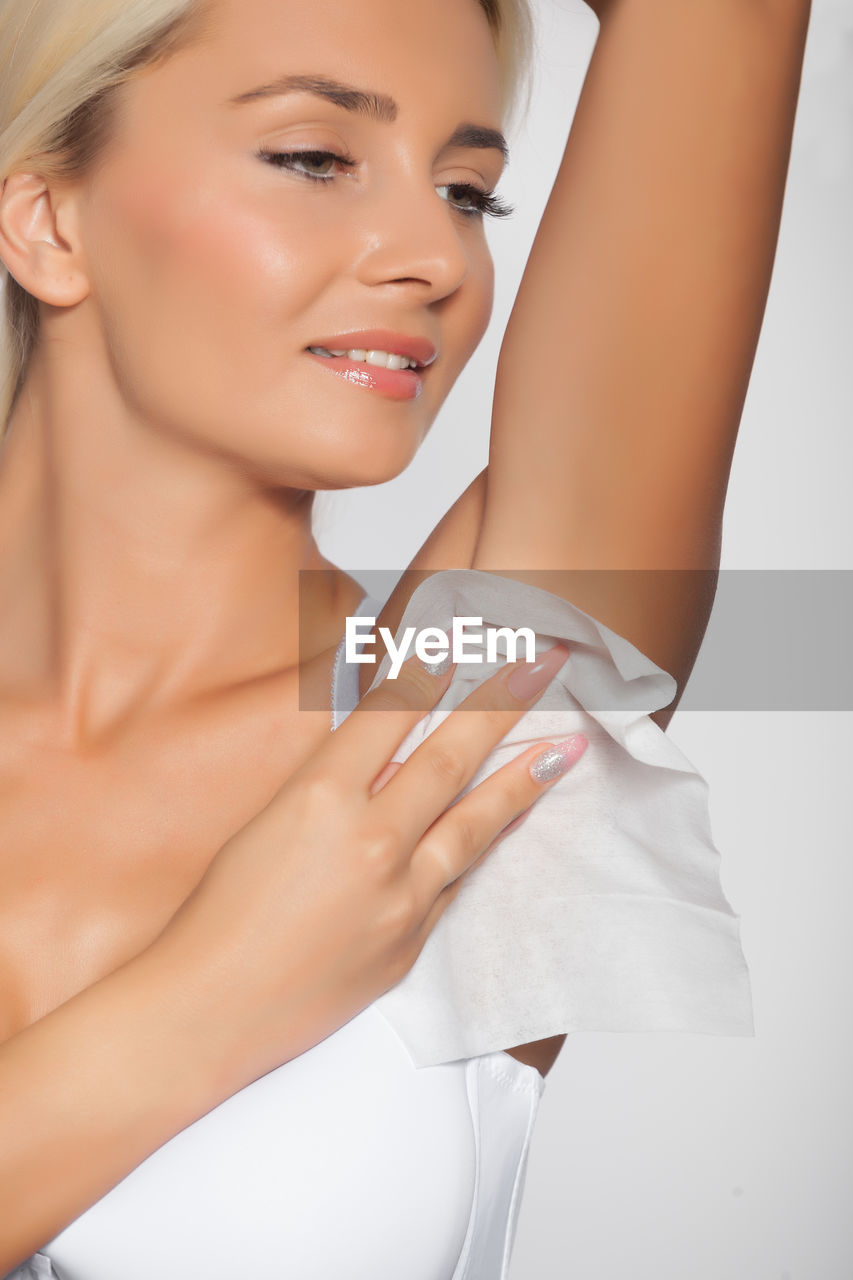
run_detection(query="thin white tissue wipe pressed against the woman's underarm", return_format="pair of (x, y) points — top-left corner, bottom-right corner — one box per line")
(333, 570), (754, 1066)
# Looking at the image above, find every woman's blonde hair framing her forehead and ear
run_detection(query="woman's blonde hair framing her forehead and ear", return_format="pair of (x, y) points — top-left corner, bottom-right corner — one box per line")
(0, 0), (533, 438)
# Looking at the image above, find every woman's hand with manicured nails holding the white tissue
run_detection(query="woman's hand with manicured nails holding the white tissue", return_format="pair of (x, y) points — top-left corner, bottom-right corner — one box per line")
(155, 645), (587, 1078)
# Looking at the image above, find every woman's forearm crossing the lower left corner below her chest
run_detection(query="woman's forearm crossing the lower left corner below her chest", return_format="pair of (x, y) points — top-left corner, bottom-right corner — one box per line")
(0, 933), (269, 1275)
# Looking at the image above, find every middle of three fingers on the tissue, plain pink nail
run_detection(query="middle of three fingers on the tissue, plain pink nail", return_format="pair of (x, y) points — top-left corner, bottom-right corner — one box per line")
(378, 644), (569, 842)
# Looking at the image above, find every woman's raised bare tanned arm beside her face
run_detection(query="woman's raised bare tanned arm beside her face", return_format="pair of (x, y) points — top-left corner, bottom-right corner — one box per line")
(473, 0), (809, 724)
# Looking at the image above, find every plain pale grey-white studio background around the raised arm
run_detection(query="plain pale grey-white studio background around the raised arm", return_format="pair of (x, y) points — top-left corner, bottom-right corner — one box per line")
(318, 0), (853, 1280)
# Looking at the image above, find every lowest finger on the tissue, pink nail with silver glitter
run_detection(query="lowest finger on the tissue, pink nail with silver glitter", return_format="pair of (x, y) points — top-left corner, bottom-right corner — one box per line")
(411, 733), (589, 915)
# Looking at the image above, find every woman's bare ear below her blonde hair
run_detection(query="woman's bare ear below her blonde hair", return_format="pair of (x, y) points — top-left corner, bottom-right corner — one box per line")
(0, 173), (88, 307)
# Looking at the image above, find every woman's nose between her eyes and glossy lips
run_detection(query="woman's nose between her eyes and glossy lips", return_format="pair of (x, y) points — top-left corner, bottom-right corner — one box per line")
(357, 168), (473, 302)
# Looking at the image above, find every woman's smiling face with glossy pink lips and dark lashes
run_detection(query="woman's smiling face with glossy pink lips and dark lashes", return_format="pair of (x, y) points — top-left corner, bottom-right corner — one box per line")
(71, 0), (503, 489)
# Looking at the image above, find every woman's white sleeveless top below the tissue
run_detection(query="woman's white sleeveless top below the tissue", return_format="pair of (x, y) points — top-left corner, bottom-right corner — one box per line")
(12, 598), (544, 1280)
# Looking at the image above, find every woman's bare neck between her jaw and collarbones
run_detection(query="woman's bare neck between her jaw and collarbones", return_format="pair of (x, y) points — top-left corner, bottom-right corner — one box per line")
(0, 362), (355, 742)
